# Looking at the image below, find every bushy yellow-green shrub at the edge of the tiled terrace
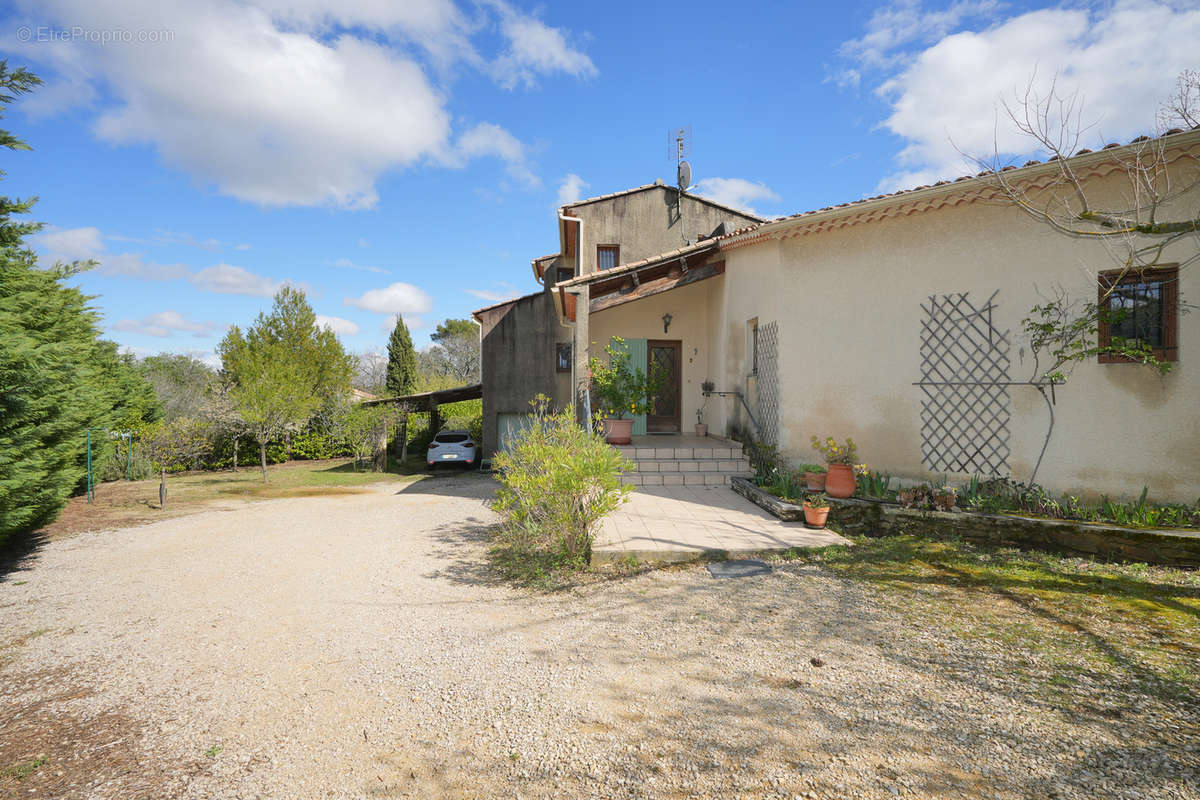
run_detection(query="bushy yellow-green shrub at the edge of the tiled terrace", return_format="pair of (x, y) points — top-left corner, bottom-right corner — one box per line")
(493, 395), (632, 572)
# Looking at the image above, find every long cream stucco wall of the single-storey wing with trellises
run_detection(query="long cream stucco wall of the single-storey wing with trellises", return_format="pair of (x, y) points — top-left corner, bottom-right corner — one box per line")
(713, 175), (1200, 503)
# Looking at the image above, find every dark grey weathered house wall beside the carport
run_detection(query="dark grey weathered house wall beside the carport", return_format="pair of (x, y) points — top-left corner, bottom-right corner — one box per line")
(478, 290), (571, 458)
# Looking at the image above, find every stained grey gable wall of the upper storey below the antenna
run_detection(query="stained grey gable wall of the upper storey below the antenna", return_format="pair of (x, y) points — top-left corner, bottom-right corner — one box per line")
(571, 186), (755, 275)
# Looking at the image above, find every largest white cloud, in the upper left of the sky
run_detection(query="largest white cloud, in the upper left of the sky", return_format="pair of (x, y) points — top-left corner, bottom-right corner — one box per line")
(11, 0), (595, 207)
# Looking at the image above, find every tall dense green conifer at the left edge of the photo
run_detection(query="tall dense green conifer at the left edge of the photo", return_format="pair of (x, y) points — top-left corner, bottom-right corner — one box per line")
(0, 61), (157, 542)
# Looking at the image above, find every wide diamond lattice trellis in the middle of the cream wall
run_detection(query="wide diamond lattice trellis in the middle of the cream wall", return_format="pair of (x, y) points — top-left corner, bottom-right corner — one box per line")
(914, 291), (1012, 475)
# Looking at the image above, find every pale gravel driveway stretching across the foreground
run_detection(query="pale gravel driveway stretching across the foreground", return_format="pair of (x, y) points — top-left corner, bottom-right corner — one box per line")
(0, 476), (1200, 800)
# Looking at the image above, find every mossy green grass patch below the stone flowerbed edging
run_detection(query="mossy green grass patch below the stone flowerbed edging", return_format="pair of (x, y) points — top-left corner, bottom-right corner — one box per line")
(784, 536), (1200, 700)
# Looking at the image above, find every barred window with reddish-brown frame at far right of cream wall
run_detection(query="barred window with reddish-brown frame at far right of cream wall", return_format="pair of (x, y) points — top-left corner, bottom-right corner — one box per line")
(1097, 266), (1180, 363)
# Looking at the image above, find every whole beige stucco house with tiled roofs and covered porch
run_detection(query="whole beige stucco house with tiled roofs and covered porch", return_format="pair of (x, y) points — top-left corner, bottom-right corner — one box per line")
(476, 130), (1200, 503)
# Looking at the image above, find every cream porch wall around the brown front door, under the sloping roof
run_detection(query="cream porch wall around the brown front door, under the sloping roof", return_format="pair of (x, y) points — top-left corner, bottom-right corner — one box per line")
(589, 278), (720, 433)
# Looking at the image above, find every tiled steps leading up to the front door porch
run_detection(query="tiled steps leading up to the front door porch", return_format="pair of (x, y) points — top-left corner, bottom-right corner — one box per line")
(617, 437), (754, 486)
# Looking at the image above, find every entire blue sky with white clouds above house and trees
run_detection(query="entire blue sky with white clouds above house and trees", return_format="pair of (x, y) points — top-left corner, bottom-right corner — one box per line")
(0, 0), (1200, 360)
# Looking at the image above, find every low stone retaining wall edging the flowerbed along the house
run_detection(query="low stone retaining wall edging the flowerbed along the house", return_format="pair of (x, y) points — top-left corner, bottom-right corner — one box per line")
(732, 477), (1200, 567)
